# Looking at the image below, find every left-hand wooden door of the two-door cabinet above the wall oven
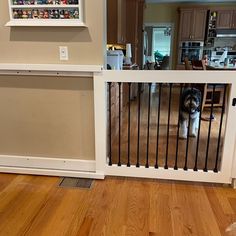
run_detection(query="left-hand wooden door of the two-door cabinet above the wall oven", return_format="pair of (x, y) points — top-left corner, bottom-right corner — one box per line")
(179, 9), (193, 41)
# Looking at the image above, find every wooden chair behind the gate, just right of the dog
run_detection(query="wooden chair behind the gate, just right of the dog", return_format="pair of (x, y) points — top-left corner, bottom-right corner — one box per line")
(192, 60), (224, 111)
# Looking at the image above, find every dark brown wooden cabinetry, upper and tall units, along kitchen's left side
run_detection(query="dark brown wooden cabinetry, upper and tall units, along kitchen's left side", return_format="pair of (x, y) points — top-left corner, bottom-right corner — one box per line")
(107, 0), (144, 68)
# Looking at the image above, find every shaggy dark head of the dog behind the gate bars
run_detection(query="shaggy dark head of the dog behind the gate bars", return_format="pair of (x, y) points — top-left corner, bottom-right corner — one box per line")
(182, 88), (201, 113)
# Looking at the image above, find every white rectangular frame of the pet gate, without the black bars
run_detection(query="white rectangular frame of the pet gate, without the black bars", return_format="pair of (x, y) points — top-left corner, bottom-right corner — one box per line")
(94, 70), (236, 184)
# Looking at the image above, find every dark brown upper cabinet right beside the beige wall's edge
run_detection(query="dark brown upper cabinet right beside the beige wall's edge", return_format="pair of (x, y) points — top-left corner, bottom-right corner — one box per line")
(107, 0), (126, 44)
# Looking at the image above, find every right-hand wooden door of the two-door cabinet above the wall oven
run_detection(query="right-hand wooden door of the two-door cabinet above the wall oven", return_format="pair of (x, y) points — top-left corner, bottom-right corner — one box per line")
(194, 9), (207, 41)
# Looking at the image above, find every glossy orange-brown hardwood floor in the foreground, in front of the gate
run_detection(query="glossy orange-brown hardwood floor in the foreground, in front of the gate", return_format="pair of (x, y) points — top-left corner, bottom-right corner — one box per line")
(0, 174), (236, 236)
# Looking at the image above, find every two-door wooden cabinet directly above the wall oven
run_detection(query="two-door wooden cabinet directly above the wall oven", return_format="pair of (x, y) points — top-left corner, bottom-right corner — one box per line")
(179, 8), (207, 41)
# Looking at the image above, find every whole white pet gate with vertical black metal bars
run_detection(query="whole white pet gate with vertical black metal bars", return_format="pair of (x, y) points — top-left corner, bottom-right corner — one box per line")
(94, 71), (236, 183)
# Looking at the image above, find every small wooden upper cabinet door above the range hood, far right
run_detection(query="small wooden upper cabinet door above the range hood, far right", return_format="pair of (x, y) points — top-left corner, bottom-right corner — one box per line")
(216, 10), (233, 29)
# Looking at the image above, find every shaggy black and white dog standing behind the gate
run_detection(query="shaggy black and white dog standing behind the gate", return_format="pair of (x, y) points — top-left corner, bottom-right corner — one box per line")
(179, 88), (201, 139)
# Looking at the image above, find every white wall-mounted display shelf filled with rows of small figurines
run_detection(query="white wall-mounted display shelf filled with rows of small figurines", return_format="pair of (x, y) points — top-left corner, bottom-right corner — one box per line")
(6, 0), (85, 26)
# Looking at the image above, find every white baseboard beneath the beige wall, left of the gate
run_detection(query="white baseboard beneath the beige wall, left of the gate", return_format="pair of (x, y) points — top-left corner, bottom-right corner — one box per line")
(0, 155), (104, 179)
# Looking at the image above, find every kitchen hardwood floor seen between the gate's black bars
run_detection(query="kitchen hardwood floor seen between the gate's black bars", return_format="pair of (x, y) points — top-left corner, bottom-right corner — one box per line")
(112, 84), (226, 170)
